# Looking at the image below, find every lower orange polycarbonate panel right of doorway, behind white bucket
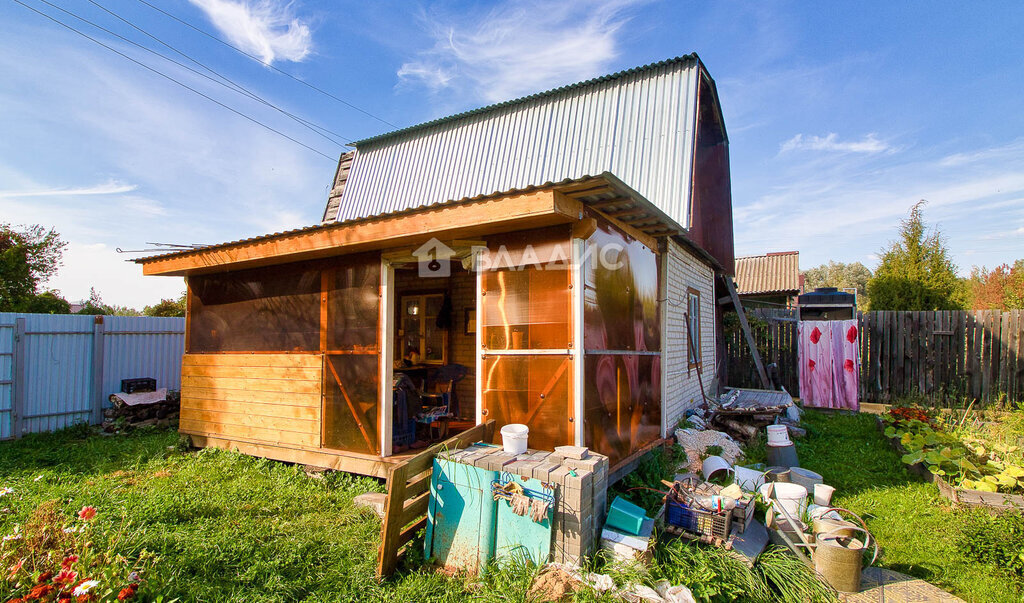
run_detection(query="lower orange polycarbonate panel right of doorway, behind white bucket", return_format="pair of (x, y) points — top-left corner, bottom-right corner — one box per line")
(480, 355), (574, 450)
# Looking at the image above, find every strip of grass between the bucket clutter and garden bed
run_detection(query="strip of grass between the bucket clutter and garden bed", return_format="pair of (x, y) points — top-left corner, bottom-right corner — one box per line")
(749, 411), (1022, 602)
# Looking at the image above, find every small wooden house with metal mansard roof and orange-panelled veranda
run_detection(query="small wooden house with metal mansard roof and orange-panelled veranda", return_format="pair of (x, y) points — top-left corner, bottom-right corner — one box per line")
(137, 55), (733, 476)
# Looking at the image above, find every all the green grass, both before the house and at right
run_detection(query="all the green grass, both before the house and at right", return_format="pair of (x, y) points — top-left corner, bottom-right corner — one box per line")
(0, 413), (1020, 602)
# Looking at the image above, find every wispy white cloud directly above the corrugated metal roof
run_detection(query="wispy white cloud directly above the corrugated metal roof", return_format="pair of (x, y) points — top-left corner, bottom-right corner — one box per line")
(397, 0), (639, 102)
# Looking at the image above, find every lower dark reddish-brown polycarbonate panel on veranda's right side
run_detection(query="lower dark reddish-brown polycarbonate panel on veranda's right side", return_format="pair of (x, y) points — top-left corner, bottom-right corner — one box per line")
(584, 354), (662, 467)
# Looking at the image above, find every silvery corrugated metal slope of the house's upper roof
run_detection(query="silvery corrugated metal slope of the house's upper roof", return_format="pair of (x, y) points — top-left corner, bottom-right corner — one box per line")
(338, 54), (700, 226)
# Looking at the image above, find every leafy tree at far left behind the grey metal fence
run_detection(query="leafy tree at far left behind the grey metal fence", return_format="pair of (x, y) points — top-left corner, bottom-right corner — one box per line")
(0, 222), (67, 312)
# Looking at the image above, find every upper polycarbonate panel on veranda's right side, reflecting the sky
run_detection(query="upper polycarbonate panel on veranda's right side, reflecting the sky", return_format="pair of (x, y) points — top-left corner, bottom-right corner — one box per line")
(584, 223), (662, 351)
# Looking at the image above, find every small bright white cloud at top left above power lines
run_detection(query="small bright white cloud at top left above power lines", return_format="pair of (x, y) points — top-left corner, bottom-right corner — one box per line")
(188, 0), (312, 63)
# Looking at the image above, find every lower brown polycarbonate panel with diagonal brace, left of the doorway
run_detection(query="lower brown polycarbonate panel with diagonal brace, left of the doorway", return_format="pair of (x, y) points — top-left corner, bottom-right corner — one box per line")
(324, 353), (380, 455)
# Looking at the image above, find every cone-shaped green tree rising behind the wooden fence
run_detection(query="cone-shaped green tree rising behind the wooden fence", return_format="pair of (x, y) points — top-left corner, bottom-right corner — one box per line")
(867, 200), (968, 310)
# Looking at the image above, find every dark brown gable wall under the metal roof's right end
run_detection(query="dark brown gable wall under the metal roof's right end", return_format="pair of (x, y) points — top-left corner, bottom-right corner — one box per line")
(689, 76), (735, 274)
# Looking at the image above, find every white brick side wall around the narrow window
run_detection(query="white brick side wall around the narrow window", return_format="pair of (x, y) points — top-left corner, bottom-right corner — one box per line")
(662, 240), (717, 434)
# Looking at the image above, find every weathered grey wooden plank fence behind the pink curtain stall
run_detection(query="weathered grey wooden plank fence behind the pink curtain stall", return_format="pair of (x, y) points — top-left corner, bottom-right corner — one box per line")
(725, 308), (1024, 405)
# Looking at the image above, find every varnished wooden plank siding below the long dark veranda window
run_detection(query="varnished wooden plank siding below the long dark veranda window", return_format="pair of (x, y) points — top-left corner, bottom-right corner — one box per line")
(179, 353), (323, 448)
